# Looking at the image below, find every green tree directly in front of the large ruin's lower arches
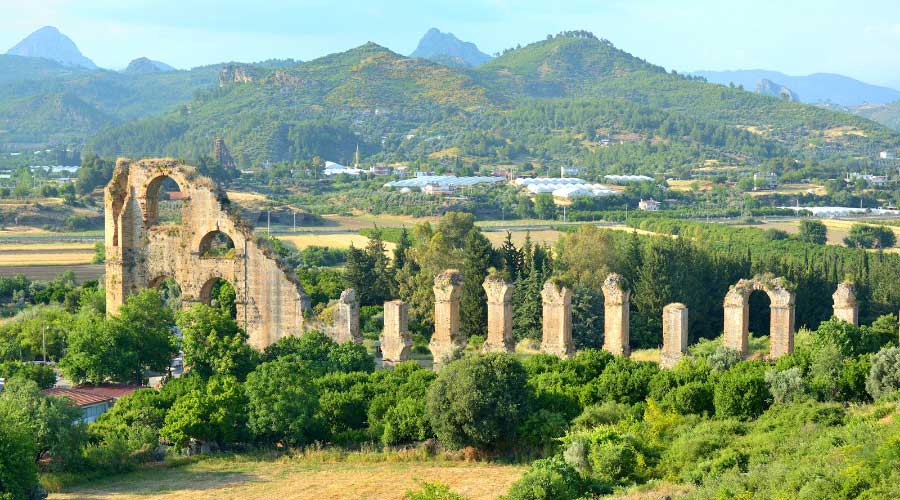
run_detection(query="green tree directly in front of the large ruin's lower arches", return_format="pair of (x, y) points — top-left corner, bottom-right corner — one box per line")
(177, 304), (258, 380)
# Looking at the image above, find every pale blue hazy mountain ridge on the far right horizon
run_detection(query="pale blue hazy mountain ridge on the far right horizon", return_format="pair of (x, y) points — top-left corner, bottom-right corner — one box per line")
(693, 69), (900, 106)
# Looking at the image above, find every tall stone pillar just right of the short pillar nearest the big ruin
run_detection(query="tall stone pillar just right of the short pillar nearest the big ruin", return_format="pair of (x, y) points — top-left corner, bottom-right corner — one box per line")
(428, 269), (466, 369)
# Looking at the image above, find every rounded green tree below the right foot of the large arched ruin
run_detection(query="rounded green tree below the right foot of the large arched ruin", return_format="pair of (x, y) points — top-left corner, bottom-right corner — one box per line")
(244, 355), (319, 445)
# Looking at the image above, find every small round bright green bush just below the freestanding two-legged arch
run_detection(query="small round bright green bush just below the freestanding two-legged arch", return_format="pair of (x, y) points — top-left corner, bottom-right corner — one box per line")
(713, 361), (771, 419)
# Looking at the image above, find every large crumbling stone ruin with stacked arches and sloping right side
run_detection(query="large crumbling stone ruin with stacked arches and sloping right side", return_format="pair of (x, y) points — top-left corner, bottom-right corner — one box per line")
(104, 159), (309, 349)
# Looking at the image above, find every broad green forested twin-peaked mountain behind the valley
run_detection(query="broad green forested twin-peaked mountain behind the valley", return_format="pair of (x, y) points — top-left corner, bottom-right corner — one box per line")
(89, 31), (900, 173)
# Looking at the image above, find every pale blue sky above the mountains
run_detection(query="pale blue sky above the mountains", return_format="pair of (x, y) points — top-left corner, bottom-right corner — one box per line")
(0, 0), (900, 88)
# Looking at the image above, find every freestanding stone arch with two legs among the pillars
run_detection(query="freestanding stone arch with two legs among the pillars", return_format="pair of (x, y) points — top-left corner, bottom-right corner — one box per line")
(724, 275), (795, 359)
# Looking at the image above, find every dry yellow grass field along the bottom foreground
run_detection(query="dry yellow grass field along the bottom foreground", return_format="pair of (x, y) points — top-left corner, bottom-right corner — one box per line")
(50, 457), (525, 500)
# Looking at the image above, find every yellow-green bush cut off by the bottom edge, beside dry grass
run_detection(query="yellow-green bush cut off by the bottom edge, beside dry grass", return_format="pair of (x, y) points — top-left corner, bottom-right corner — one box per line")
(504, 456), (608, 500)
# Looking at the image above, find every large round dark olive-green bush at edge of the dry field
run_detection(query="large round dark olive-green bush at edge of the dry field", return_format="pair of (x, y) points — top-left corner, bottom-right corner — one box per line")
(427, 353), (527, 449)
